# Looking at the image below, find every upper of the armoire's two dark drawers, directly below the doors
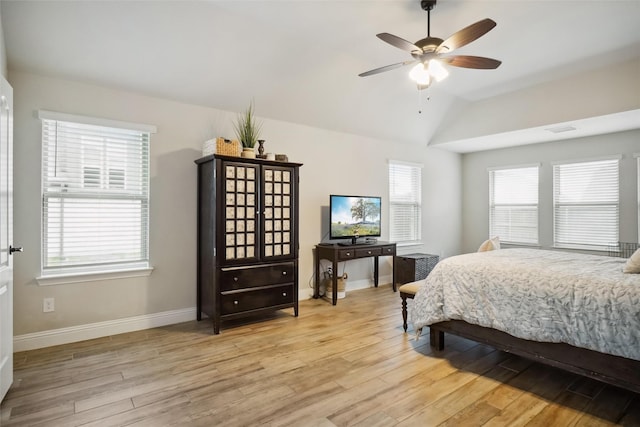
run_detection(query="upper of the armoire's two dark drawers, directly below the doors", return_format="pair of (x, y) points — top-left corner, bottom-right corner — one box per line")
(220, 262), (295, 292)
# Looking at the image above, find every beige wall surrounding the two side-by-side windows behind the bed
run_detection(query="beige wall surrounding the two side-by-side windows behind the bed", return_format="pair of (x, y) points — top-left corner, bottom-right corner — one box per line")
(462, 130), (640, 252)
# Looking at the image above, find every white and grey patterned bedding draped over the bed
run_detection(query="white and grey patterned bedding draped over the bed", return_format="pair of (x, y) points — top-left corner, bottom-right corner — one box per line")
(411, 249), (640, 360)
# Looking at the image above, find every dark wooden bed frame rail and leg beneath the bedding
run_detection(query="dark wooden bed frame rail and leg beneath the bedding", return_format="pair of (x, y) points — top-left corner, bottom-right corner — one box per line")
(429, 320), (640, 393)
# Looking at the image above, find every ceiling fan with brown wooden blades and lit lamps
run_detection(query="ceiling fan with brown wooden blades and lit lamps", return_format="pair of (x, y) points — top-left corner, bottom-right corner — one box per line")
(359, 0), (502, 90)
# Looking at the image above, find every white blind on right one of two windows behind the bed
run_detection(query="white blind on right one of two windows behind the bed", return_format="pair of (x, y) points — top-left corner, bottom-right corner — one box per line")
(553, 159), (620, 250)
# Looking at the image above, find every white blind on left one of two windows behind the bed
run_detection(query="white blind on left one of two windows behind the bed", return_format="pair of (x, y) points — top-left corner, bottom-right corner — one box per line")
(489, 166), (539, 245)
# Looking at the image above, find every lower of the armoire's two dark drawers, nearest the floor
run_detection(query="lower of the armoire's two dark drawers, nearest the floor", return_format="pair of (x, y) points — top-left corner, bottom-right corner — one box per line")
(221, 284), (294, 316)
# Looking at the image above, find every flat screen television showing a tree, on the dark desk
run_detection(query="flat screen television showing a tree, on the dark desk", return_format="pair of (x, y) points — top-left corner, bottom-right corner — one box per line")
(329, 194), (382, 245)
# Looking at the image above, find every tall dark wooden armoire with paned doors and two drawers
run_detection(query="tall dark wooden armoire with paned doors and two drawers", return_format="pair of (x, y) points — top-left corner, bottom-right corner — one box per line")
(196, 154), (302, 334)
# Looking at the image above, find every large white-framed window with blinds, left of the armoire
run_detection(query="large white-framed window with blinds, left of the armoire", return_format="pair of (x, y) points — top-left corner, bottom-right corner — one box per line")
(40, 111), (155, 277)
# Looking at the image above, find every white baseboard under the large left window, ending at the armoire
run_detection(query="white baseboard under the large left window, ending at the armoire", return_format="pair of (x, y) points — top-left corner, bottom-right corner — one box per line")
(13, 307), (196, 352)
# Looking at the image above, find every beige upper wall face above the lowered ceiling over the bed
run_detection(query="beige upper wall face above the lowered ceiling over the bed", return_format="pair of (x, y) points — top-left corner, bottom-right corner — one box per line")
(431, 59), (640, 145)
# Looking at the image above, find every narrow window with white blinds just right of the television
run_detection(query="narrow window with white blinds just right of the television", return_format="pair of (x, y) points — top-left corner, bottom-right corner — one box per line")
(389, 160), (422, 243)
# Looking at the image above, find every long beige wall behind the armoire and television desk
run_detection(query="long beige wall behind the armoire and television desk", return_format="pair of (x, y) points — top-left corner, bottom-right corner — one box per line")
(9, 70), (461, 342)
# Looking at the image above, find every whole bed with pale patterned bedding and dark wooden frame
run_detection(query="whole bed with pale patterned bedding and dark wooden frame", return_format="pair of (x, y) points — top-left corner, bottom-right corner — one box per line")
(411, 248), (640, 393)
